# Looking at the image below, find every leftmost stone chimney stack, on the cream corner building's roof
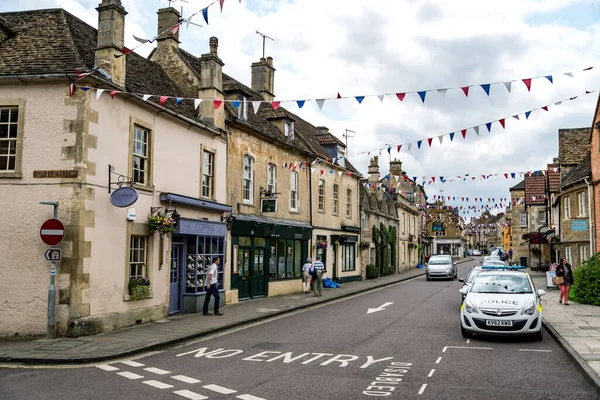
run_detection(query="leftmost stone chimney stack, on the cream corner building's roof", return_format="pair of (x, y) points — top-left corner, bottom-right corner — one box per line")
(95, 0), (127, 88)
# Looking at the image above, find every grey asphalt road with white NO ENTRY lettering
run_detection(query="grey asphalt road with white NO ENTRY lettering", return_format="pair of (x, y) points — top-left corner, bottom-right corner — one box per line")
(0, 263), (599, 400)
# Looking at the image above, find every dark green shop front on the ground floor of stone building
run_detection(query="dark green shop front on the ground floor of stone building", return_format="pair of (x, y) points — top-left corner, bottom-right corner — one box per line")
(231, 215), (313, 300)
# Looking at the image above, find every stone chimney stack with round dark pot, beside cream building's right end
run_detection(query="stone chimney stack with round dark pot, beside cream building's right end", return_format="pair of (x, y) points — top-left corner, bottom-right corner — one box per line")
(198, 36), (225, 129)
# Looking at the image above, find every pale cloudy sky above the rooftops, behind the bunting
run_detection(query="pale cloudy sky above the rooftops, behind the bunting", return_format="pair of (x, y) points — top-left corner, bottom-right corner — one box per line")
(0, 0), (600, 222)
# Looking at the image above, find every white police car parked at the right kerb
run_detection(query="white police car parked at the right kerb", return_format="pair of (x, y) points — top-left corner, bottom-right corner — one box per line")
(460, 265), (546, 340)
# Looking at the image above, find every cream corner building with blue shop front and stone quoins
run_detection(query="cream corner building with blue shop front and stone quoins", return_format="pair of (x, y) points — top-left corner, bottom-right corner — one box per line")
(0, 0), (231, 336)
